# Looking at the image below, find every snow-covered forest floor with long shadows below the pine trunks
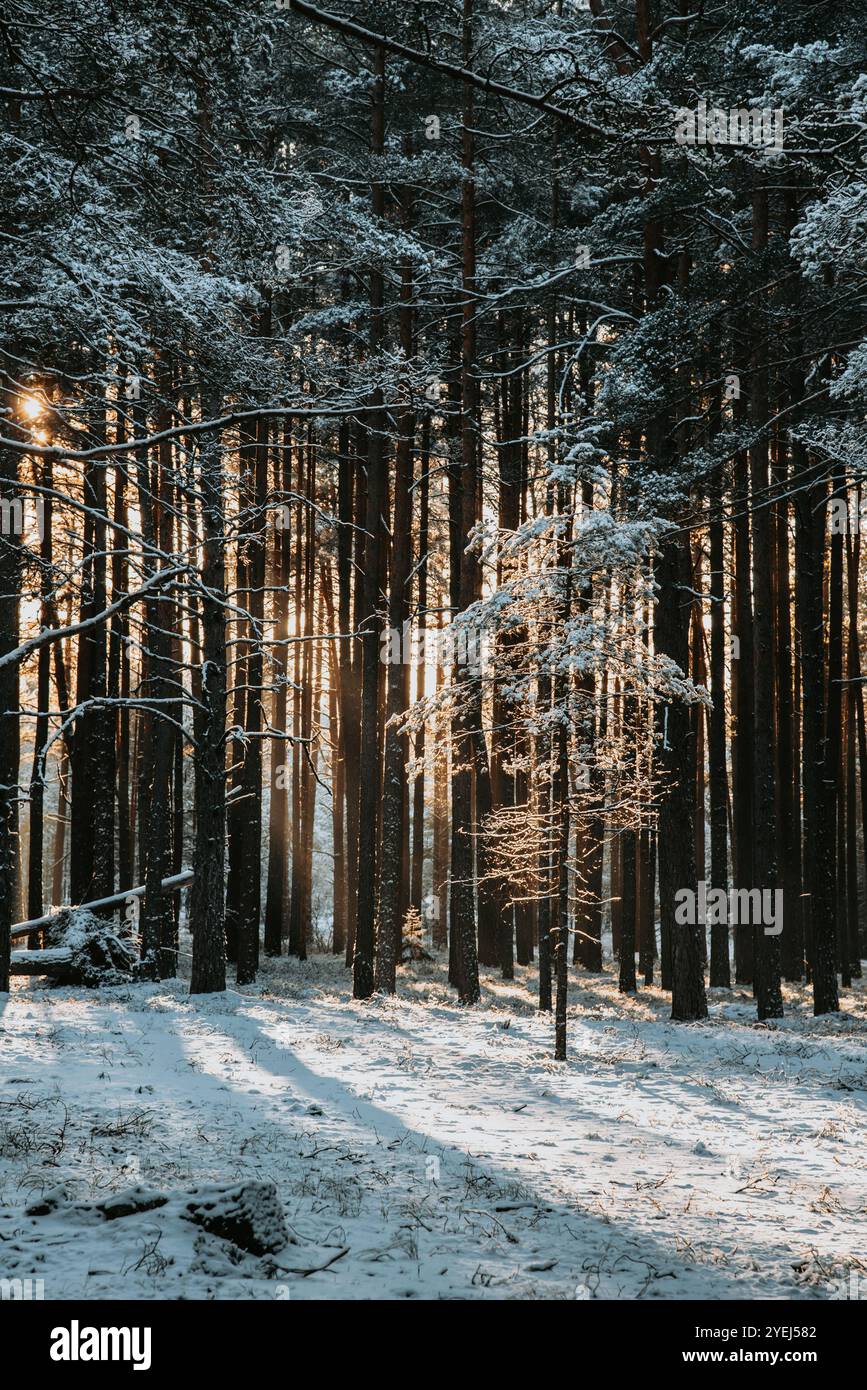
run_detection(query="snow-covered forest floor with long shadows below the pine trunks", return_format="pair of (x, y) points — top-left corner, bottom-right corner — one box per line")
(0, 956), (867, 1298)
